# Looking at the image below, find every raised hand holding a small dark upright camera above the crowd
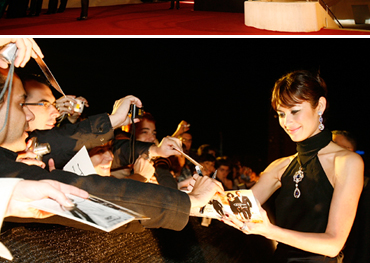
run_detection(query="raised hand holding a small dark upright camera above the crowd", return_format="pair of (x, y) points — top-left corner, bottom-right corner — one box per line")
(109, 95), (143, 129)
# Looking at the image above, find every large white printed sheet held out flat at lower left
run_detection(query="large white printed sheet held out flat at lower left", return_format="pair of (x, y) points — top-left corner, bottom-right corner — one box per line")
(30, 194), (149, 232)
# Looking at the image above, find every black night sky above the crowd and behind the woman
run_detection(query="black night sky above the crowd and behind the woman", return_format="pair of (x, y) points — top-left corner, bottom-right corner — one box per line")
(16, 37), (370, 171)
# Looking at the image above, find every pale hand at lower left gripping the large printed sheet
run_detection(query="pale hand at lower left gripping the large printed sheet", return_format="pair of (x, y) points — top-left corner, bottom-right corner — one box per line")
(5, 180), (89, 218)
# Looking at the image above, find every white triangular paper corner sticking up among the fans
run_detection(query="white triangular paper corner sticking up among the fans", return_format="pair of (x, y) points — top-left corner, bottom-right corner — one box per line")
(63, 146), (96, 176)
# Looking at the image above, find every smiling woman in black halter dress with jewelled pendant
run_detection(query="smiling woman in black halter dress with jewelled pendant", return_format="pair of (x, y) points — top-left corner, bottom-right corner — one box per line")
(224, 71), (364, 262)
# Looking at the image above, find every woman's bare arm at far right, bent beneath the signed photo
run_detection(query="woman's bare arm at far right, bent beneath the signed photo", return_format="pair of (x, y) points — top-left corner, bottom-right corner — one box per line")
(234, 152), (364, 257)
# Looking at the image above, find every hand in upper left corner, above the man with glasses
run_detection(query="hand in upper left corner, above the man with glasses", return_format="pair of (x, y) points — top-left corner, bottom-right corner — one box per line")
(0, 38), (44, 68)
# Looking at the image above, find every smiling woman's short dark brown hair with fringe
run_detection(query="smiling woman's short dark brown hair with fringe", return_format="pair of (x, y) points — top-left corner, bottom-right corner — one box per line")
(271, 70), (327, 110)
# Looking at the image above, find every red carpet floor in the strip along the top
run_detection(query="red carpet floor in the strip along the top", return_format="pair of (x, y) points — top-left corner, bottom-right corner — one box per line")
(0, 2), (370, 36)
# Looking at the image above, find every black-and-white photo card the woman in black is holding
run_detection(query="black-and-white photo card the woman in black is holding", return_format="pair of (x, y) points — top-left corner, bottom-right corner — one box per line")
(195, 190), (262, 223)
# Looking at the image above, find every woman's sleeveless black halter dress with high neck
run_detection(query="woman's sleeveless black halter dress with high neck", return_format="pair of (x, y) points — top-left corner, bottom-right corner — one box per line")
(274, 130), (340, 263)
